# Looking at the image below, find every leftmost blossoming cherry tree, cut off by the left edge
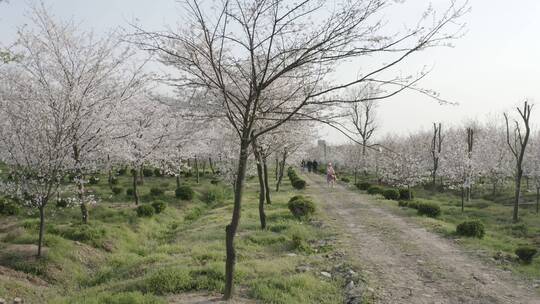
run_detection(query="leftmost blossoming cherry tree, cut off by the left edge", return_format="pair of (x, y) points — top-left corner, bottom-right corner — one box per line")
(0, 67), (72, 257)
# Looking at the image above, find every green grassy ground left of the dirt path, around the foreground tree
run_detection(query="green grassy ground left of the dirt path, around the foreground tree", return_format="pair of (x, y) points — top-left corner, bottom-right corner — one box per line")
(0, 170), (352, 303)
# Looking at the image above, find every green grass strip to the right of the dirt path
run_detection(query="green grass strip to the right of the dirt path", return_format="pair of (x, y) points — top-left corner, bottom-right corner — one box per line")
(338, 177), (540, 280)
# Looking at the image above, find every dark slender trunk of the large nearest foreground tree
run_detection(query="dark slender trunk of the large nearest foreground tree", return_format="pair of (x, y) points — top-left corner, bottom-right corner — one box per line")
(223, 140), (249, 300)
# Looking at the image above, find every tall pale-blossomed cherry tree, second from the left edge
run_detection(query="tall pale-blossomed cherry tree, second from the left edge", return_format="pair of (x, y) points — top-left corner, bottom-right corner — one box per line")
(16, 6), (148, 223)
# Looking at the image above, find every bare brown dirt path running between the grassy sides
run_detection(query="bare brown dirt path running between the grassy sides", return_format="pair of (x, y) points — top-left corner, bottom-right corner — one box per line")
(307, 174), (540, 304)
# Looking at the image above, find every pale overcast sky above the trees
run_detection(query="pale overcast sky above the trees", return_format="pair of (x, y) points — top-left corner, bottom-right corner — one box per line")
(0, 0), (540, 142)
